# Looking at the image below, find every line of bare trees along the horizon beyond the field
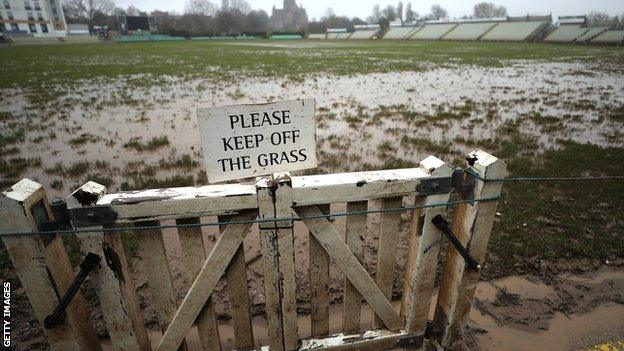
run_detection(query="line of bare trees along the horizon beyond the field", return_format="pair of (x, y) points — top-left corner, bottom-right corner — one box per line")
(63, 0), (624, 36)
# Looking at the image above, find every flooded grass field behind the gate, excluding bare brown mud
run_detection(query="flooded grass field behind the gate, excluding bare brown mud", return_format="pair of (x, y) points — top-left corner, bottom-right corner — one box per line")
(0, 41), (624, 349)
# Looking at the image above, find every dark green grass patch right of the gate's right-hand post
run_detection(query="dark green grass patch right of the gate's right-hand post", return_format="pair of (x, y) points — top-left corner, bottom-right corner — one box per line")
(488, 141), (624, 275)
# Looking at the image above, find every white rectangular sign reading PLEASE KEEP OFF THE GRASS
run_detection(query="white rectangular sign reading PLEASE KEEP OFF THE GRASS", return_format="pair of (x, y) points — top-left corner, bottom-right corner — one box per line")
(197, 99), (316, 183)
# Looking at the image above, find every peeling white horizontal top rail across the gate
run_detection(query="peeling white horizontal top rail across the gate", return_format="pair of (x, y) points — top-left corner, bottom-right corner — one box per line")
(98, 168), (438, 222)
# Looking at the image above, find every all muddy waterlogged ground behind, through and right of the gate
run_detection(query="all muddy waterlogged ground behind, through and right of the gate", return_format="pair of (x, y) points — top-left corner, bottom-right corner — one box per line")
(0, 43), (624, 350)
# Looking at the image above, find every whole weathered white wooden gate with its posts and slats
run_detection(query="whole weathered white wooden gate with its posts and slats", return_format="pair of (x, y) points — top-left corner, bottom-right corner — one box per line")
(0, 150), (506, 351)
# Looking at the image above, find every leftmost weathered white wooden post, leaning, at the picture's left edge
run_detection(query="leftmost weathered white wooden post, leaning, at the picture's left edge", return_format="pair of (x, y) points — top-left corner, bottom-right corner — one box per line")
(0, 179), (95, 350)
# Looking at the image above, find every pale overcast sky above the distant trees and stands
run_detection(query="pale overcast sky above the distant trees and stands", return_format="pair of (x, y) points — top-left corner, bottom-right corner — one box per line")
(116, 0), (624, 19)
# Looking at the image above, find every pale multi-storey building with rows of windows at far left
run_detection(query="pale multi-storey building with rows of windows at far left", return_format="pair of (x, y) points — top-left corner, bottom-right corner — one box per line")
(0, 0), (67, 36)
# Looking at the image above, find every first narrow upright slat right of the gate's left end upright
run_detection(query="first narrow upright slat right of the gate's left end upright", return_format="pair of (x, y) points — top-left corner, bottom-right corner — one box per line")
(134, 221), (186, 349)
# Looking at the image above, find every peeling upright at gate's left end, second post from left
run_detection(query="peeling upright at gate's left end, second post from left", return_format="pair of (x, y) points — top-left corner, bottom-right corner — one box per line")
(67, 182), (152, 351)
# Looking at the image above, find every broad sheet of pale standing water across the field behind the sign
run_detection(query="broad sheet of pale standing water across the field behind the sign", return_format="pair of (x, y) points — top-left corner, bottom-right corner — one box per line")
(0, 61), (624, 195)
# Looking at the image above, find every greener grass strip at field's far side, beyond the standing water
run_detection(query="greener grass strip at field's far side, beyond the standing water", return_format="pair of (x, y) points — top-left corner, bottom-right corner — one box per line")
(0, 40), (624, 87)
